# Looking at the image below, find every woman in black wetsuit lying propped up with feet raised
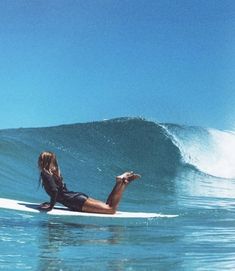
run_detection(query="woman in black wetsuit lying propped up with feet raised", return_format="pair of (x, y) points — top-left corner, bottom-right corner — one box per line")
(38, 152), (140, 214)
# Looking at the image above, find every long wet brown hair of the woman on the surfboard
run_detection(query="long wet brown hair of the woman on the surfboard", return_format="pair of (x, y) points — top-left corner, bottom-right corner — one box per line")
(38, 151), (61, 186)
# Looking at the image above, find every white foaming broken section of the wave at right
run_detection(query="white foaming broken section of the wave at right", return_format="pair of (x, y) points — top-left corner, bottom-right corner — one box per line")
(163, 124), (235, 179)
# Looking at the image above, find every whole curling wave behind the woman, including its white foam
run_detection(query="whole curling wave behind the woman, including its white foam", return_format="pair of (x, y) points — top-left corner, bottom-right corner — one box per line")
(0, 118), (235, 210)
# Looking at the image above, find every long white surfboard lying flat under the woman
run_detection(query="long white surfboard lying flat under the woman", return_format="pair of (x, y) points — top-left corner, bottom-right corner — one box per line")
(0, 198), (177, 219)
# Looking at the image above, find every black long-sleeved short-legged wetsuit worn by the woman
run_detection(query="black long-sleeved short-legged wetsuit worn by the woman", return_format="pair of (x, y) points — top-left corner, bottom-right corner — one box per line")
(41, 171), (88, 211)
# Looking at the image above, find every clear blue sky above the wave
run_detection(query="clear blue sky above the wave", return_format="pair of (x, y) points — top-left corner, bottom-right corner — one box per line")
(0, 0), (235, 129)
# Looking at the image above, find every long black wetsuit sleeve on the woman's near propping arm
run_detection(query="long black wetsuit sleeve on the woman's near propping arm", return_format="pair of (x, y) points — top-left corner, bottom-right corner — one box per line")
(42, 172), (58, 209)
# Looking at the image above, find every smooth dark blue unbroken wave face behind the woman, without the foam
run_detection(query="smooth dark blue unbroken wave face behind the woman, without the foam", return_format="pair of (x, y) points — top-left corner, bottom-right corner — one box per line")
(0, 118), (181, 206)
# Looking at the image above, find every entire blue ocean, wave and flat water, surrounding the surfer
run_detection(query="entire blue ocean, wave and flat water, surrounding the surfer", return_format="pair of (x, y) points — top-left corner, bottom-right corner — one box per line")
(0, 118), (235, 271)
